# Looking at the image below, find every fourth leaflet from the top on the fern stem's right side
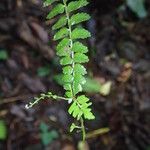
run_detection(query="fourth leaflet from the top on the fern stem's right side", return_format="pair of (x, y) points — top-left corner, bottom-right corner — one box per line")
(72, 42), (88, 53)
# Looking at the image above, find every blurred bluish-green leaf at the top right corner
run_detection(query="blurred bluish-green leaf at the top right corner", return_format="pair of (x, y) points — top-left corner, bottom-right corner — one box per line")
(126, 0), (147, 18)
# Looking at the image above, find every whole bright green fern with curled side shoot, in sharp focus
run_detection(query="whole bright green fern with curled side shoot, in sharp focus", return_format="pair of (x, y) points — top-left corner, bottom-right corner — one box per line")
(26, 0), (95, 140)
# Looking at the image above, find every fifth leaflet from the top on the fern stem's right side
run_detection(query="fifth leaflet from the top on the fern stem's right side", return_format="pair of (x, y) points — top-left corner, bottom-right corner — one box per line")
(74, 53), (89, 63)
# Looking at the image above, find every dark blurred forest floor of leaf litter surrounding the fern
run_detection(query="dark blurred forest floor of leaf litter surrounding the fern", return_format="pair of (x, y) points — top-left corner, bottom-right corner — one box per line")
(0, 0), (150, 150)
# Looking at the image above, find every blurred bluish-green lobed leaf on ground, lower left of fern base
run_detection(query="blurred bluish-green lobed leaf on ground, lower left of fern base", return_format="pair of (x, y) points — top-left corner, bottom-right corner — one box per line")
(40, 122), (59, 146)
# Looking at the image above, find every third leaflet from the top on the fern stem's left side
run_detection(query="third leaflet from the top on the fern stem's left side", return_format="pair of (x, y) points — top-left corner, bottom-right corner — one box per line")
(52, 16), (67, 30)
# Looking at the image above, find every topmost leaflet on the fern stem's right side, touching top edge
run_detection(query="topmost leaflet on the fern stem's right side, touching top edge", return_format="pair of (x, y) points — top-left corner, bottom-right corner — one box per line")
(68, 0), (88, 12)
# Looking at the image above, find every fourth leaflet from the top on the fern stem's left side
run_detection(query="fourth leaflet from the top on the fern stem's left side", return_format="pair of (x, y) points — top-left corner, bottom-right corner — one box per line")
(54, 27), (69, 41)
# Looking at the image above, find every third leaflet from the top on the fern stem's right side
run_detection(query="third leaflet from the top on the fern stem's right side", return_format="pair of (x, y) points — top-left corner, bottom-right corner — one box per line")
(72, 28), (91, 40)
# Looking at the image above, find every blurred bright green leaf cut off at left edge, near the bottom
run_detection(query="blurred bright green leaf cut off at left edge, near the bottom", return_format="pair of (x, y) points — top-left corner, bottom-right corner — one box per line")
(0, 120), (7, 140)
